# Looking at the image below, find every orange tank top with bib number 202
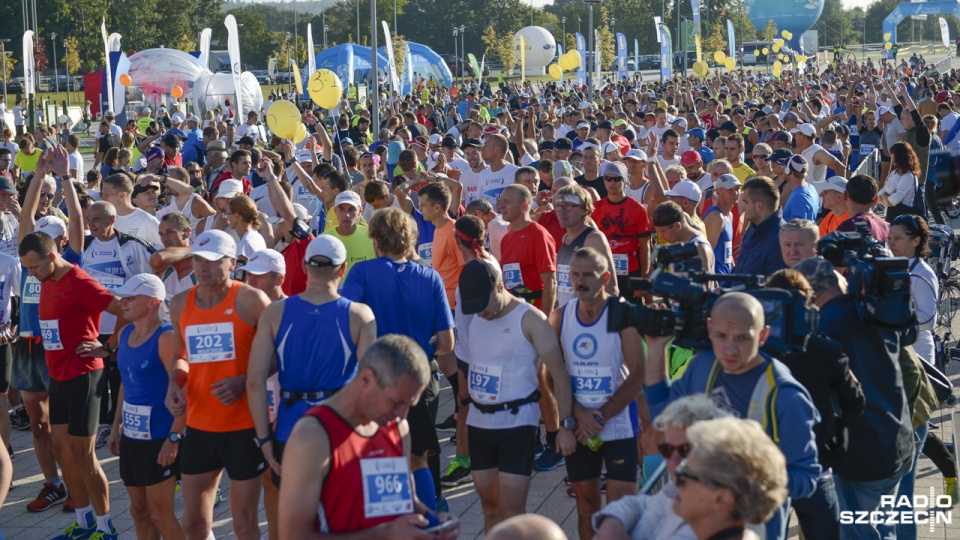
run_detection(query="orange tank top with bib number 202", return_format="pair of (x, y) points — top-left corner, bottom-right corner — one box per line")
(180, 281), (257, 433)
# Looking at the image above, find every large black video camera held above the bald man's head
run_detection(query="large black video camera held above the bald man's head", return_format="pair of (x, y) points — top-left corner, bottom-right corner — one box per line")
(607, 244), (819, 356)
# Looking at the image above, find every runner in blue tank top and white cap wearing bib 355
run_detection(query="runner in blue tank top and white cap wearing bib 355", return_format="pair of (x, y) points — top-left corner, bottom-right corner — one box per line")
(104, 274), (186, 538)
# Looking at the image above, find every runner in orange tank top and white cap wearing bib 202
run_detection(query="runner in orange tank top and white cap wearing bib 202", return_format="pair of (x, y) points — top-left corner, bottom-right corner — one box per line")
(166, 230), (270, 540)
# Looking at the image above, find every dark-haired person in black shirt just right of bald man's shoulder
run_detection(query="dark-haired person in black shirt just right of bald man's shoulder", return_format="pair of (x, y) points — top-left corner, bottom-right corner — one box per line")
(765, 268), (866, 540)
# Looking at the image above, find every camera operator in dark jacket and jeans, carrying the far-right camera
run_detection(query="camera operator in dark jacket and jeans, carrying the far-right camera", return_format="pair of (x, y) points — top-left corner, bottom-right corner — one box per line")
(796, 256), (914, 538)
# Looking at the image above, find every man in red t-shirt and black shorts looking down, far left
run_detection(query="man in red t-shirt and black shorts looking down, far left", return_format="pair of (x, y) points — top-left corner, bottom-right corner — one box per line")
(19, 233), (127, 538)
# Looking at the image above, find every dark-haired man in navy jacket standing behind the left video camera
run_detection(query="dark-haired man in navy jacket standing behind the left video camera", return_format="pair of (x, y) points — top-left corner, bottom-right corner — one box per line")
(734, 176), (787, 276)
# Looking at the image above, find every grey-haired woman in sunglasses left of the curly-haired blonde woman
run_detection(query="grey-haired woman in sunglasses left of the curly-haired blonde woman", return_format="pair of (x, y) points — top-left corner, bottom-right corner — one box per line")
(593, 394), (727, 540)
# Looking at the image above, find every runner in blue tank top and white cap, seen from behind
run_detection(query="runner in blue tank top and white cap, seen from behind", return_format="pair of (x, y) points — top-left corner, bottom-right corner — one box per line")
(247, 235), (377, 486)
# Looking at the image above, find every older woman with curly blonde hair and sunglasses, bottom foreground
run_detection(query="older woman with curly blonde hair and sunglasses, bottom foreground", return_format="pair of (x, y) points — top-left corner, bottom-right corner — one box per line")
(673, 418), (787, 540)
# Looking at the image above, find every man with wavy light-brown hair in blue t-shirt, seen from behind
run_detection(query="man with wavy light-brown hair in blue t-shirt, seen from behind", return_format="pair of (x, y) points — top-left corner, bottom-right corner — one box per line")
(341, 208), (453, 511)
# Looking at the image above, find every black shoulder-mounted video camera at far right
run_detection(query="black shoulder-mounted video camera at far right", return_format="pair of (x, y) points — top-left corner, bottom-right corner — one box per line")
(817, 223), (917, 338)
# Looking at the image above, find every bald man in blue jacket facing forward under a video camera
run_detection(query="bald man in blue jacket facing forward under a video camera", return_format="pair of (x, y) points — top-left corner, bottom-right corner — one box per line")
(644, 292), (822, 540)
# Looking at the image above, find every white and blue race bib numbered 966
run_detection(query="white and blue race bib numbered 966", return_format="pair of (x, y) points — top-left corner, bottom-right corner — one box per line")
(360, 457), (413, 519)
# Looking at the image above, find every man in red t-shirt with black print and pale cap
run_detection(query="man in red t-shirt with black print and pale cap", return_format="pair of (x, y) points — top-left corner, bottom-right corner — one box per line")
(593, 161), (651, 298)
